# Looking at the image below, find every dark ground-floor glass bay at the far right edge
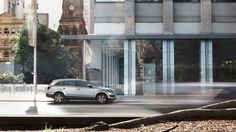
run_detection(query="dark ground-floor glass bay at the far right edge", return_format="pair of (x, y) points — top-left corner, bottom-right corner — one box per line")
(213, 40), (236, 82)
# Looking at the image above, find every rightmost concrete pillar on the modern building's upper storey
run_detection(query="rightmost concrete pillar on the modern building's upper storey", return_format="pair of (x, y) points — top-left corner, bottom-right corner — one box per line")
(201, 0), (212, 33)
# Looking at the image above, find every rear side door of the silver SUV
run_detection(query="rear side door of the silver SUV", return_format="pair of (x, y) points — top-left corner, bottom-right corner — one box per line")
(61, 80), (78, 98)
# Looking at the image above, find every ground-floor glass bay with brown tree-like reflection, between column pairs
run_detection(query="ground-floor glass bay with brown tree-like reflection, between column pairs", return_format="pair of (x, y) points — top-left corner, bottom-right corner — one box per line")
(136, 40), (163, 95)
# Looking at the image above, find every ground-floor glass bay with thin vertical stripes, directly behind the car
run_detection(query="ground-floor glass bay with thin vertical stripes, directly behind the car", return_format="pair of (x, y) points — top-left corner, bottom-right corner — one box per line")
(84, 40), (124, 94)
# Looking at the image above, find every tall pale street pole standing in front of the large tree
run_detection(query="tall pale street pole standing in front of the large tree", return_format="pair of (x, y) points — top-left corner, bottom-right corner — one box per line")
(32, 0), (37, 102)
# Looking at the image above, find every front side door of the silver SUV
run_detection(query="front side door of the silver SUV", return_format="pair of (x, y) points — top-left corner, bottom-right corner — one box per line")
(77, 81), (94, 99)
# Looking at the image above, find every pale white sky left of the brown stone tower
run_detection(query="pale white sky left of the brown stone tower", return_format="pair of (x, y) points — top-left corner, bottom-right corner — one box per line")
(0, 0), (62, 30)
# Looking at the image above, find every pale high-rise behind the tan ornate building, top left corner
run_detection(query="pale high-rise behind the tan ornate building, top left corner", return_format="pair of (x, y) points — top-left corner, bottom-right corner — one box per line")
(4, 0), (25, 19)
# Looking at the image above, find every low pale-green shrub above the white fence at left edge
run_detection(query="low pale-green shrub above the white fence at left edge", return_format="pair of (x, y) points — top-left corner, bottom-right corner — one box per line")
(0, 71), (25, 83)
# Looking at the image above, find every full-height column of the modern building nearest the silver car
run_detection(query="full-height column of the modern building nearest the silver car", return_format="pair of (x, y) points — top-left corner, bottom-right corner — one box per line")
(124, 0), (136, 96)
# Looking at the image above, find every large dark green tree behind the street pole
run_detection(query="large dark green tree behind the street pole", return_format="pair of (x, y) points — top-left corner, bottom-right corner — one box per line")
(11, 24), (74, 83)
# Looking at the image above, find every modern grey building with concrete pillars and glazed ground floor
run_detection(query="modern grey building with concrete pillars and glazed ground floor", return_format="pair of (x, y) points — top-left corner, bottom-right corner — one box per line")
(63, 0), (236, 95)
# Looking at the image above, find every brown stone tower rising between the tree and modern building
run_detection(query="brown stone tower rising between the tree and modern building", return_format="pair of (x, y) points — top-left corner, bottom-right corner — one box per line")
(58, 0), (87, 78)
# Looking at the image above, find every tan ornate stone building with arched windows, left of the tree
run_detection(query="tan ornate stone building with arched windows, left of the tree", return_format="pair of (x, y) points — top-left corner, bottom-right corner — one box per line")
(0, 13), (24, 73)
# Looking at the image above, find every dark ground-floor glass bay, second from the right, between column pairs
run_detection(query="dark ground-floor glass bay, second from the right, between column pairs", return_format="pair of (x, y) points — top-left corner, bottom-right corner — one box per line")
(174, 40), (200, 82)
